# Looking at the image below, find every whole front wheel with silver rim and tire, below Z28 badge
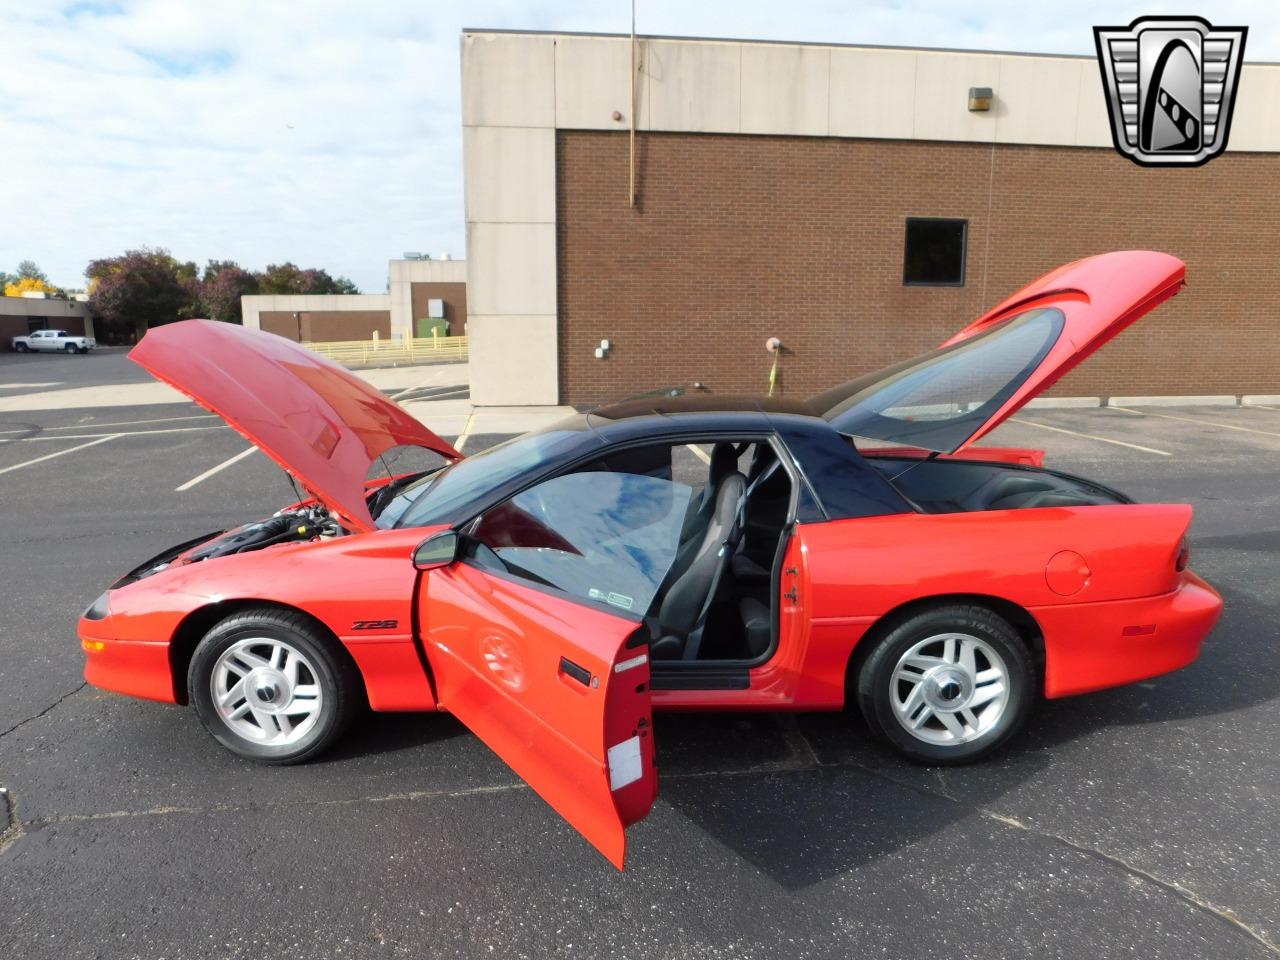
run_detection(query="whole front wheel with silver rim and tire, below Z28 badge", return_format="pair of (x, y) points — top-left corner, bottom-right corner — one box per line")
(187, 608), (358, 764)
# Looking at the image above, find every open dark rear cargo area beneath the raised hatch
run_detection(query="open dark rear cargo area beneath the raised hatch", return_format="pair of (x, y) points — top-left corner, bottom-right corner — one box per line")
(867, 456), (1133, 513)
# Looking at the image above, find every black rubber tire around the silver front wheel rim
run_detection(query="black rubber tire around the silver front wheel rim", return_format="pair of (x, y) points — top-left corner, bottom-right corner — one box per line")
(187, 607), (361, 765)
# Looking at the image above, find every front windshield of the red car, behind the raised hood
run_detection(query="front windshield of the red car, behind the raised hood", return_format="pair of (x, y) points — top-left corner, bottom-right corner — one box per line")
(374, 429), (581, 530)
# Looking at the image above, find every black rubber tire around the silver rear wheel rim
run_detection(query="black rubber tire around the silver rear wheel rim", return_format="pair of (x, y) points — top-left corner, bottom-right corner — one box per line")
(852, 604), (1037, 765)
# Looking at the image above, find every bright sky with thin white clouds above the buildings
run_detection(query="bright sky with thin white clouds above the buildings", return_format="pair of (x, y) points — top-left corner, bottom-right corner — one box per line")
(0, 0), (1280, 292)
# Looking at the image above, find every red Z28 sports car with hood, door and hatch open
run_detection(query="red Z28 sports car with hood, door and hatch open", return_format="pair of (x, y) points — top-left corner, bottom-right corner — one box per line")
(79, 252), (1221, 867)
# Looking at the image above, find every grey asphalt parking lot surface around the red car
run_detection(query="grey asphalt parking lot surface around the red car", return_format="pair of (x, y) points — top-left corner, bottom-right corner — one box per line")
(0, 355), (1280, 960)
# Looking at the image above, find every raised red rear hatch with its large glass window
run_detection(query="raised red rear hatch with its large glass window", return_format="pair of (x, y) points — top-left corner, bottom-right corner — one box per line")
(810, 250), (1187, 453)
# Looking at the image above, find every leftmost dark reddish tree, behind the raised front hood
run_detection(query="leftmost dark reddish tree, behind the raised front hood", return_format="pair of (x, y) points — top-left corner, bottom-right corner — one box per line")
(84, 247), (200, 343)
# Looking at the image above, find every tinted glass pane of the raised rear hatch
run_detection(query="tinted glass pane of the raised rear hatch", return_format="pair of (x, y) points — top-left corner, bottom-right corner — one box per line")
(813, 307), (1065, 453)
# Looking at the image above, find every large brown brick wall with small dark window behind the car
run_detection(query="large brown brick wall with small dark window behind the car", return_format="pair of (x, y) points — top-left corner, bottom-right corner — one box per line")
(556, 131), (1280, 403)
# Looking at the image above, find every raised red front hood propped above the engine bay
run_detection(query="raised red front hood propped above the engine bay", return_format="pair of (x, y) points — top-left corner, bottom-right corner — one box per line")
(129, 320), (462, 531)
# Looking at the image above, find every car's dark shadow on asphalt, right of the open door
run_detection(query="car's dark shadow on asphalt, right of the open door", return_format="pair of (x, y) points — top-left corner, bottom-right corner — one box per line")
(655, 590), (1280, 890)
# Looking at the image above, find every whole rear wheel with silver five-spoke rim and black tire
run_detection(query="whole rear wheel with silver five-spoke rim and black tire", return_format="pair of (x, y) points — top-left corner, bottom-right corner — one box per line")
(856, 604), (1036, 764)
